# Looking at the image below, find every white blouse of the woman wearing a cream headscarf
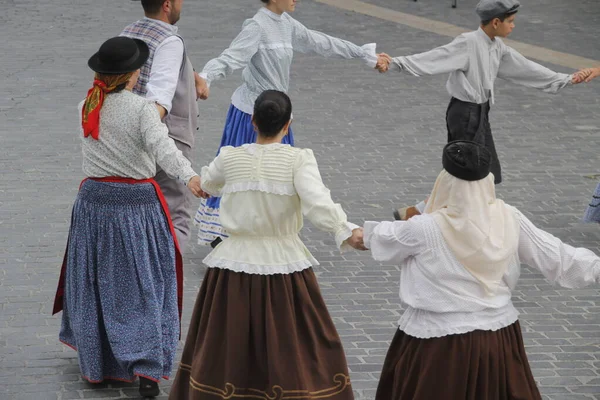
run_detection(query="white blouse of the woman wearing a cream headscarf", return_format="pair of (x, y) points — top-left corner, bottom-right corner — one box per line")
(364, 210), (600, 338)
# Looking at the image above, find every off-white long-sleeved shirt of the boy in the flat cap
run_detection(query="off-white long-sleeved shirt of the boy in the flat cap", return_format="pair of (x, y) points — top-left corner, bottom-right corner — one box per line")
(392, 28), (573, 104)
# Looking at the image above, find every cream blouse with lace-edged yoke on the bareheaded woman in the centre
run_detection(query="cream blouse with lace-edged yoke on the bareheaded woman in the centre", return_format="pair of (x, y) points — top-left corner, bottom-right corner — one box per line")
(201, 143), (357, 275)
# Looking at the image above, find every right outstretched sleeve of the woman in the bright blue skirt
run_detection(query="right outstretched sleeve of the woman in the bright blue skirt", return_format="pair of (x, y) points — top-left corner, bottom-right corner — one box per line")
(289, 17), (377, 68)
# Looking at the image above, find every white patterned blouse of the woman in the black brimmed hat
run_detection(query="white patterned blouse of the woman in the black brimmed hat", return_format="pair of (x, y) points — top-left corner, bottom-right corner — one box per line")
(78, 90), (197, 184)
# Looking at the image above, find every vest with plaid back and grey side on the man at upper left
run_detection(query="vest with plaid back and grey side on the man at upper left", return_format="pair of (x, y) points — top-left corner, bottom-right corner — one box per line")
(121, 18), (198, 147)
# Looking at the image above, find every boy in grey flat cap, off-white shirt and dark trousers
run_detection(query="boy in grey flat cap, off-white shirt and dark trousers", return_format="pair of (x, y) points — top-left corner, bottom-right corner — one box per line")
(388, 0), (582, 220)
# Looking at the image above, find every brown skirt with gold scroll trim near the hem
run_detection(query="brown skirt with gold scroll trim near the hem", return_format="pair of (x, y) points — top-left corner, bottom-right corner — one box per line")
(169, 268), (354, 400)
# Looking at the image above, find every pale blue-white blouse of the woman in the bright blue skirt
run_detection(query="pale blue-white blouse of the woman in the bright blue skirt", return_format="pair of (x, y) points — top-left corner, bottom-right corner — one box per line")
(200, 7), (377, 114)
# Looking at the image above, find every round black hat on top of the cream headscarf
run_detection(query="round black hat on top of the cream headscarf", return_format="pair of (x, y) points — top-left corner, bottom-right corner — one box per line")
(442, 140), (492, 181)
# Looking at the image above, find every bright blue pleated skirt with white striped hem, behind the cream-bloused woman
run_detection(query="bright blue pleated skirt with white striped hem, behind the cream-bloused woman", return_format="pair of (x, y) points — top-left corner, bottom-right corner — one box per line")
(194, 104), (294, 245)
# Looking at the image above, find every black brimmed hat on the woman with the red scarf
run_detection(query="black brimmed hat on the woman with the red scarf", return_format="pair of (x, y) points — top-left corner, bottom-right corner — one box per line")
(88, 36), (150, 75)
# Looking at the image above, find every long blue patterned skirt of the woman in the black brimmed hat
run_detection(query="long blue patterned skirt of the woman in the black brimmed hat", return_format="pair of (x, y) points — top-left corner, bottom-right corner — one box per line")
(59, 180), (179, 382)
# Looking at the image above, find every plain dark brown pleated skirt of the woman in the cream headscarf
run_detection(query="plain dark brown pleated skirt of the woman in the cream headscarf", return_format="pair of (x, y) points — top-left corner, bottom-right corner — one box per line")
(376, 321), (542, 400)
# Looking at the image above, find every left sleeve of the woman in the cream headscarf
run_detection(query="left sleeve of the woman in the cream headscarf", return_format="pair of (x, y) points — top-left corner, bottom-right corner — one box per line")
(364, 221), (420, 264)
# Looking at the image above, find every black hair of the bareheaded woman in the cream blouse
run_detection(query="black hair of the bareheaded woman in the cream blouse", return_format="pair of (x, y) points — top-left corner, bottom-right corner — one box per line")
(252, 90), (292, 137)
